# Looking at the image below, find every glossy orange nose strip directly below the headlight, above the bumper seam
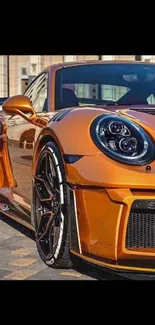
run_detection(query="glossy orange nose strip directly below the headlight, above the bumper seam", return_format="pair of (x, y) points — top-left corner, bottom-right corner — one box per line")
(66, 154), (155, 189)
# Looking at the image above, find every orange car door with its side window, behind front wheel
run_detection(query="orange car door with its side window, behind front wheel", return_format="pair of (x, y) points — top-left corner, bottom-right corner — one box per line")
(7, 72), (48, 203)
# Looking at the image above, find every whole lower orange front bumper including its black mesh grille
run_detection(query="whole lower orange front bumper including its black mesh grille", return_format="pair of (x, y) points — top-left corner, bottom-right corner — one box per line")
(71, 187), (155, 273)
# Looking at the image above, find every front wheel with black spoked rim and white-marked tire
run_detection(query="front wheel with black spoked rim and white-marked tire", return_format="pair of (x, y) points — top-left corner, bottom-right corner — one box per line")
(33, 141), (72, 268)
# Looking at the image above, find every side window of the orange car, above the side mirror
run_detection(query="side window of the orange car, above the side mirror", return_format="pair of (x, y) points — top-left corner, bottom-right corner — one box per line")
(25, 73), (48, 113)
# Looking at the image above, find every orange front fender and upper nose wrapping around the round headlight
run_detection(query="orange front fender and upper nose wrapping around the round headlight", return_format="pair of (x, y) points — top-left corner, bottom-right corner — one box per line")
(34, 108), (155, 188)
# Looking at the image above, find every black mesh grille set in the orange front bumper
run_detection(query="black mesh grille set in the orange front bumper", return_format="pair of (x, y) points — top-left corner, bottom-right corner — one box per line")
(126, 210), (155, 249)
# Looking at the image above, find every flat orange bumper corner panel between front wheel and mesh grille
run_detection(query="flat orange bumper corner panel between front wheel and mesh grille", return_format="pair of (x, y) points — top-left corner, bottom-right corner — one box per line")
(75, 189), (123, 260)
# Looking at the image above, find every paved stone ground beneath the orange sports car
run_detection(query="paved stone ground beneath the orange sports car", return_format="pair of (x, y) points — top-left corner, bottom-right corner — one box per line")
(0, 215), (154, 280)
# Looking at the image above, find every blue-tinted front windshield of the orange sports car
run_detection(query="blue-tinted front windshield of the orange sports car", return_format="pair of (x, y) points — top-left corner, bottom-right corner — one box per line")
(56, 63), (155, 109)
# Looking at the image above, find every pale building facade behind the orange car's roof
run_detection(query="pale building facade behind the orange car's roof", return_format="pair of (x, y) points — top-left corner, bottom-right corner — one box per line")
(0, 55), (155, 97)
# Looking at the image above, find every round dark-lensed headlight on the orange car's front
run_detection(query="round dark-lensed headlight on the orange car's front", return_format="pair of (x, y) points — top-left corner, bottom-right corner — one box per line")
(91, 115), (155, 165)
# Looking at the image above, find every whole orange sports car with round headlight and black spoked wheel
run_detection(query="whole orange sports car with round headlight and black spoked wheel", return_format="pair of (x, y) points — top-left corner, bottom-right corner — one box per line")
(0, 61), (155, 273)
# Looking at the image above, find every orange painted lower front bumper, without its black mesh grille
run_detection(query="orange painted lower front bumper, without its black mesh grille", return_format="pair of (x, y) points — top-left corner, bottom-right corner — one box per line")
(72, 189), (155, 272)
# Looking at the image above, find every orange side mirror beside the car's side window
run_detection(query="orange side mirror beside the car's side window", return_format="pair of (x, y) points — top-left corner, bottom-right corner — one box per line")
(2, 95), (36, 122)
